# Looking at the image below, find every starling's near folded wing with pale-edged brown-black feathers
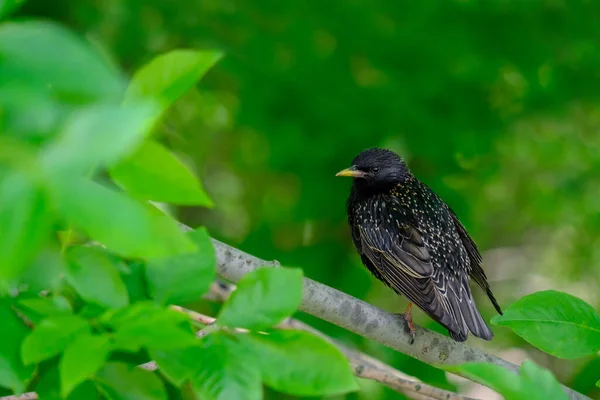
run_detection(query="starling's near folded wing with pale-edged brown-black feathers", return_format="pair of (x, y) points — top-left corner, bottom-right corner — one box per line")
(353, 203), (466, 338)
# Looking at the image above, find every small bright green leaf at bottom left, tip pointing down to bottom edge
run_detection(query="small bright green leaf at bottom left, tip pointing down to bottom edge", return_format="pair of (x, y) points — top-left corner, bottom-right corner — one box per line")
(60, 334), (111, 397)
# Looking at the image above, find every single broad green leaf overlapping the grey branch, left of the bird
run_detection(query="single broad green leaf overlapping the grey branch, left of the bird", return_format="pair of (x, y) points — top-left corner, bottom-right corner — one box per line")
(217, 268), (302, 330)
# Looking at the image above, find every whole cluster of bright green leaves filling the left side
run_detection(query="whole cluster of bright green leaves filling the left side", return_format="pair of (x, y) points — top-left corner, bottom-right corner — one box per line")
(0, 17), (357, 400)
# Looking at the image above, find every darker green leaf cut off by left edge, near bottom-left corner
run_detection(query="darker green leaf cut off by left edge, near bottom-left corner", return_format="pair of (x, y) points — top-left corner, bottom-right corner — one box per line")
(0, 298), (34, 393)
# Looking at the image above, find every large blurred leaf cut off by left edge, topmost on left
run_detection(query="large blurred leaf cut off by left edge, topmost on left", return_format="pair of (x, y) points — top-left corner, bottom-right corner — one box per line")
(0, 21), (125, 102)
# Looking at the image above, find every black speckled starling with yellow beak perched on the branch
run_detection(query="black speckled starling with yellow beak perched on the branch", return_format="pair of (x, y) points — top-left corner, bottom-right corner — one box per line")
(336, 148), (502, 342)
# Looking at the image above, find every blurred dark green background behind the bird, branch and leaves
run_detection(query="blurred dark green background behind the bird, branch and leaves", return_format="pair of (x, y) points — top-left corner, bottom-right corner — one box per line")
(19, 0), (600, 399)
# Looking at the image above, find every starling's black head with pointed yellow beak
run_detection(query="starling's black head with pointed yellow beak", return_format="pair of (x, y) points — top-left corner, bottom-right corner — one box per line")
(336, 148), (412, 191)
